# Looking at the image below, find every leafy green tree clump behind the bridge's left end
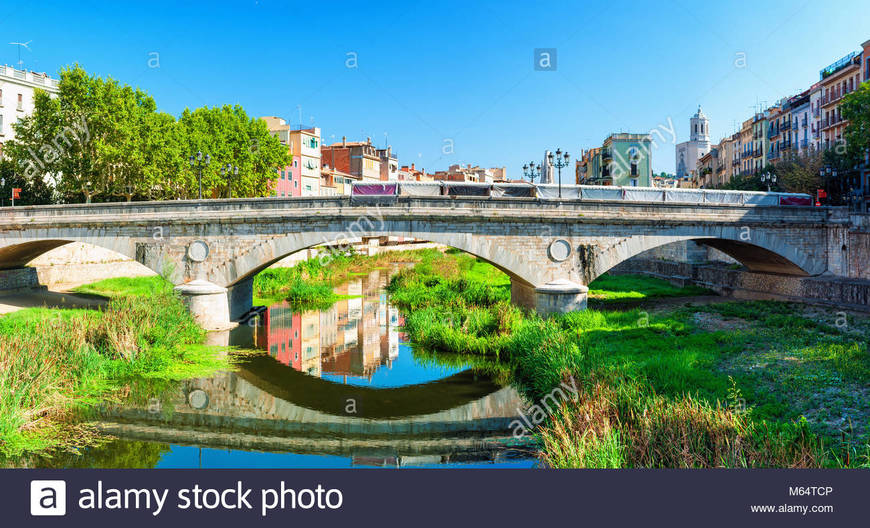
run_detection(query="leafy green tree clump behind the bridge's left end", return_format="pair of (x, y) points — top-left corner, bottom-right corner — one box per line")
(5, 65), (290, 203)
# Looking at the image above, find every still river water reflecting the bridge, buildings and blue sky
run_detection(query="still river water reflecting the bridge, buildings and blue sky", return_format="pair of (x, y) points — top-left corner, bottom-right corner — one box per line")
(55, 269), (535, 468)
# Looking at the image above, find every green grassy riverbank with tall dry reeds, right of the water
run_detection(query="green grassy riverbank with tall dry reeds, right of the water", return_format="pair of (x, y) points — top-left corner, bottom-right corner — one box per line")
(390, 250), (870, 467)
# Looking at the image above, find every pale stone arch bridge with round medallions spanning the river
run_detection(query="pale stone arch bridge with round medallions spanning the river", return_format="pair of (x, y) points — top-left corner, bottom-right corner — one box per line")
(0, 197), (849, 329)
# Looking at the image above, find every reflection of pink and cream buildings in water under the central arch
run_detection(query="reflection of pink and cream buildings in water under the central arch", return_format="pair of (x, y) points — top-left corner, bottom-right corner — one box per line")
(255, 271), (403, 379)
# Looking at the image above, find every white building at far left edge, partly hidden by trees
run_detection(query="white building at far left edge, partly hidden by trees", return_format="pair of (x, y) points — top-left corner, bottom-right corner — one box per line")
(0, 64), (60, 155)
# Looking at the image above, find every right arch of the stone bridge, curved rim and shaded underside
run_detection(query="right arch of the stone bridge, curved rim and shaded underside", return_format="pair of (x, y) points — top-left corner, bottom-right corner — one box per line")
(584, 227), (826, 284)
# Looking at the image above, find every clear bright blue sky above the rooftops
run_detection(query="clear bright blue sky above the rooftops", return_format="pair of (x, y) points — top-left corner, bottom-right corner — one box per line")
(0, 0), (870, 177)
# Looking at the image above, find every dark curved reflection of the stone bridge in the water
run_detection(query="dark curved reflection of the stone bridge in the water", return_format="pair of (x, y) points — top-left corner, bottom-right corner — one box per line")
(101, 356), (527, 465)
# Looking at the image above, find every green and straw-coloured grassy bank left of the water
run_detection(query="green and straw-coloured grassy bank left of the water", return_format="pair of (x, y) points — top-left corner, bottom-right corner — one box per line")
(0, 277), (228, 456)
